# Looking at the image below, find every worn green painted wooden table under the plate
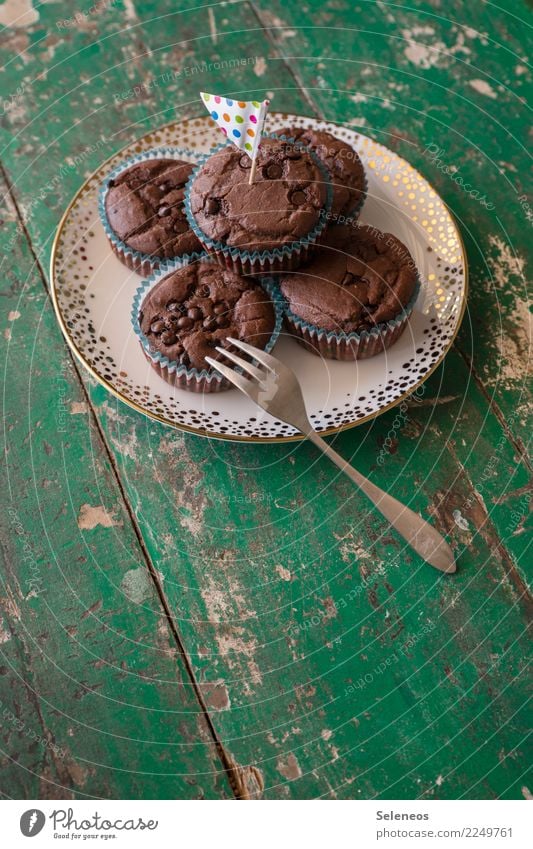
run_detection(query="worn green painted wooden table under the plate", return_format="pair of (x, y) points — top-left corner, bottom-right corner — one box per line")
(0, 0), (533, 799)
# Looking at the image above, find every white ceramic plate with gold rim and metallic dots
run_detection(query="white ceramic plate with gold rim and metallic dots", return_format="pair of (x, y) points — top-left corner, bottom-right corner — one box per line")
(51, 113), (467, 442)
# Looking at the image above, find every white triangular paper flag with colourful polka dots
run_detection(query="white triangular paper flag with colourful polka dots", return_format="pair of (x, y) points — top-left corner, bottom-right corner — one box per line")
(200, 91), (269, 160)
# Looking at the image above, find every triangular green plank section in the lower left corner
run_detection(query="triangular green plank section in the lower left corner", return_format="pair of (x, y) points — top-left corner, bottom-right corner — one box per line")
(0, 176), (232, 798)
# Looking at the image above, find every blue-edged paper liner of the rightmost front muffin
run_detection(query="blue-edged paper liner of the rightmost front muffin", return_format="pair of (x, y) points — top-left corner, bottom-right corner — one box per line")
(280, 276), (421, 360)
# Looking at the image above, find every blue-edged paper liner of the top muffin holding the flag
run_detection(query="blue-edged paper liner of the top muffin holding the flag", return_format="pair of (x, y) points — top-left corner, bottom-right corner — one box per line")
(185, 133), (333, 274)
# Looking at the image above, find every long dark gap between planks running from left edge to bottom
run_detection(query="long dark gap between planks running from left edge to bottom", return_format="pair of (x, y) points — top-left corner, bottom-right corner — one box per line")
(0, 163), (263, 799)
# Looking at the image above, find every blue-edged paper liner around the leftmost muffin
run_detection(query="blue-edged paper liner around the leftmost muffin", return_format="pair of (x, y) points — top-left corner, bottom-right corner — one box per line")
(98, 147), (202, 276)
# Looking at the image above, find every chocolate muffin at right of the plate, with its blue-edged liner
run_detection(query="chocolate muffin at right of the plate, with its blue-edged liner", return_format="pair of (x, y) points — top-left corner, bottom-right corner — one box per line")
(280, 225), (418, 359)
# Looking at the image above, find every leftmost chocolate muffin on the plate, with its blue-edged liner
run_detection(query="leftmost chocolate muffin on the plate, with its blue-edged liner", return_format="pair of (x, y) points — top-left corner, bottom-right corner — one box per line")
(103, 157), (202, 274)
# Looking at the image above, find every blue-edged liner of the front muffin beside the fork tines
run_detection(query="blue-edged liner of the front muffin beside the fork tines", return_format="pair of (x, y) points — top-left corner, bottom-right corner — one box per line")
(131, 253), (283, 392)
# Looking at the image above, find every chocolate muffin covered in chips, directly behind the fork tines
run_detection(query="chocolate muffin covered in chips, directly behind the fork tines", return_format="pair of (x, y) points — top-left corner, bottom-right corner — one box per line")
(134, 260), (281, 391)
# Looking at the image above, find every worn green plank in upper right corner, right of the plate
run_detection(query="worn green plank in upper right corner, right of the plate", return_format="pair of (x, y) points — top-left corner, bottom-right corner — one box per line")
(253, 0), (533, 449)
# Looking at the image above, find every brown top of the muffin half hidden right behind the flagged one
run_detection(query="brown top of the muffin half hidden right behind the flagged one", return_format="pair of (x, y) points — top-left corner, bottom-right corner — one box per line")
(279, 127), (366, 221)
